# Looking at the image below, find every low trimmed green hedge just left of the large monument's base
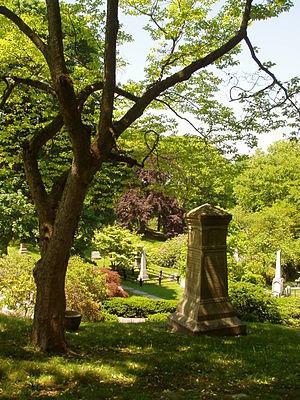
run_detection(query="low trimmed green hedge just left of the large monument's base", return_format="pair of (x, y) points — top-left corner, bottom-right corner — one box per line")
(103, 297), (178, 318)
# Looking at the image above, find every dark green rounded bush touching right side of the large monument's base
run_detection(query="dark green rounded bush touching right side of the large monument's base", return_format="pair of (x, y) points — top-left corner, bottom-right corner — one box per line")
(228, 282), (281, 323)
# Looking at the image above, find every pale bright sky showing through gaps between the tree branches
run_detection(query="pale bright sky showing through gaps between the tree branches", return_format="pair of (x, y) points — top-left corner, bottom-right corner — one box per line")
(118, 0), (300, 153)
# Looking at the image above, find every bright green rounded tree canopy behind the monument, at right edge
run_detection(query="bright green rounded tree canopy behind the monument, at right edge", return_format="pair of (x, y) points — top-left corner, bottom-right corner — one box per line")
(230, 141), (300, 282)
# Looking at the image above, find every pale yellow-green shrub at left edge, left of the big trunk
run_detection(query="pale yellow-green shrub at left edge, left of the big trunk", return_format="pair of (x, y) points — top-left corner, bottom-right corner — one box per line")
(0, 253), (35, 316)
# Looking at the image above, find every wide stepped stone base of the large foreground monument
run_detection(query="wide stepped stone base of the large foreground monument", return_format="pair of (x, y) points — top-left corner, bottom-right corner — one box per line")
(167, 298), (246, 336)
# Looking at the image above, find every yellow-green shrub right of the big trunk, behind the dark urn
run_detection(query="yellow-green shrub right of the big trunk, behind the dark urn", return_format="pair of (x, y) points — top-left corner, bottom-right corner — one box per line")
(65, 256), (108, 321)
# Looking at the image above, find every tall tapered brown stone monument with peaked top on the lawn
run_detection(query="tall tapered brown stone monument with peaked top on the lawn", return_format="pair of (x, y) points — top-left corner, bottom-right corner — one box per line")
(167, 204), (246, 335)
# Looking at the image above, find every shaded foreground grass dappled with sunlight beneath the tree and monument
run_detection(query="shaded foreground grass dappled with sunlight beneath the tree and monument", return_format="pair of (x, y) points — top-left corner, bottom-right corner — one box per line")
(0, 315), (300, 400)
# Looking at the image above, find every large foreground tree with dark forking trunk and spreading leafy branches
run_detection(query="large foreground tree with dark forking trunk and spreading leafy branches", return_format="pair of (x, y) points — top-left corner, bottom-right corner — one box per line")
(0, 0), (291, 351)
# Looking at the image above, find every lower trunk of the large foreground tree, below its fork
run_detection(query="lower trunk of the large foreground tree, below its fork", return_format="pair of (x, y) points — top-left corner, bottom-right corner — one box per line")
(31, 172), (89, 352)
